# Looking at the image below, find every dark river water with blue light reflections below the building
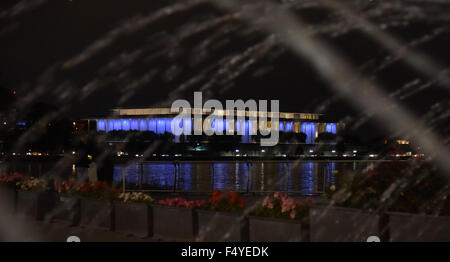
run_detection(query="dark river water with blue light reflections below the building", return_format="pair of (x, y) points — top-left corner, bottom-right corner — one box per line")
(0, 161), (374, 195)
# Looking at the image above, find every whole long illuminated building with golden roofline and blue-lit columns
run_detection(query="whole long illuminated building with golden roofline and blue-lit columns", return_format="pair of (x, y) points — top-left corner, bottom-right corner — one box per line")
(88, 108), (342, 144)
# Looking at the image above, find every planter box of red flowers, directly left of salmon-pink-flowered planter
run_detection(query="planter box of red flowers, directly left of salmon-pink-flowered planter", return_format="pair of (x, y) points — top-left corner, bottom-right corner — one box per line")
(197, 190), (249, 241)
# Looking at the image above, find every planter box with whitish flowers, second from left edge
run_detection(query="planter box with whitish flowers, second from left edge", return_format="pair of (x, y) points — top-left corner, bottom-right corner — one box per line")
(16, 177), (56, 220)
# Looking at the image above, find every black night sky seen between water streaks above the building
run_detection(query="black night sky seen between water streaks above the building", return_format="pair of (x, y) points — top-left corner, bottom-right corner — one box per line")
(0, 0), (450, 141)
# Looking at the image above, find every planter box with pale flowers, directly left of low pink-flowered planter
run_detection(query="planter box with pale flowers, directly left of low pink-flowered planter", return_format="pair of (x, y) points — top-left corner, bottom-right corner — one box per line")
(114, 193), (154, 237)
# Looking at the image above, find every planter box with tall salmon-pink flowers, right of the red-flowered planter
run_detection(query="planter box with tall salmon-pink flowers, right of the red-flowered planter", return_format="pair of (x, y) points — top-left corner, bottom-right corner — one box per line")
(250, 192), (312, 242)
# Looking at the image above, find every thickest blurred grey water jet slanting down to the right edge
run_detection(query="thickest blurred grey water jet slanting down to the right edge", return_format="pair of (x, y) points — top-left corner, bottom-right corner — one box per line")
(214, 0), (450, 174)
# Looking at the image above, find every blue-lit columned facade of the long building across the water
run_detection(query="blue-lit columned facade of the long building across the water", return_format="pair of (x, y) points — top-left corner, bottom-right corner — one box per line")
(90, 109), (339, 144)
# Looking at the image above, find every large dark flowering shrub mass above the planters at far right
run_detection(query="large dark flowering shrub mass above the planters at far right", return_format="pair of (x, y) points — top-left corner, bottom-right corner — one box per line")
(328, 162), (450, 215)
